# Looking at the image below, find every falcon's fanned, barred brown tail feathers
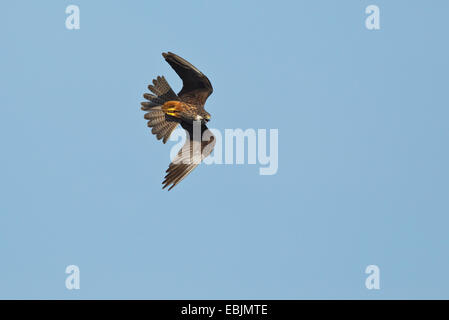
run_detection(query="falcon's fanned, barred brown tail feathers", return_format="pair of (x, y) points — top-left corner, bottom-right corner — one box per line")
(141, 77), (179, 143)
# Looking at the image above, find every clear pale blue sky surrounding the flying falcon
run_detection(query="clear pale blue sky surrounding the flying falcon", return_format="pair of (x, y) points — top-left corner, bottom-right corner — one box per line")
(0, 0), (449, 299)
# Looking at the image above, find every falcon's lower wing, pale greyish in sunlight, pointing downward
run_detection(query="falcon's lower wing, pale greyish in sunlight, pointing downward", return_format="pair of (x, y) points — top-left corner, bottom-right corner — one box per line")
(162, 122), (215, 190)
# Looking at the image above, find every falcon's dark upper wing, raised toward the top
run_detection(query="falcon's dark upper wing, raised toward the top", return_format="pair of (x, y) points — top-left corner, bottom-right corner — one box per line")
(162, 52), (213, 106)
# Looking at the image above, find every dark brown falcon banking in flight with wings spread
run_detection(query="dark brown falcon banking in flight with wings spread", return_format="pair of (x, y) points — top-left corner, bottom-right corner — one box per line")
(141, 52), (215, 190)
